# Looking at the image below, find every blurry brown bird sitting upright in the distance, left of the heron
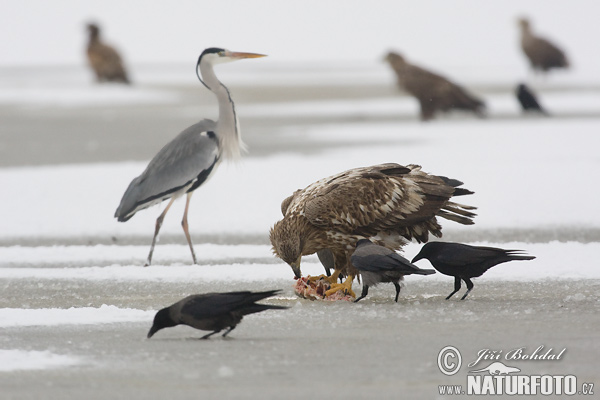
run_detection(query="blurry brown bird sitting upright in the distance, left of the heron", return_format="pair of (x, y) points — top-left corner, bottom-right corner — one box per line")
(87, 24), (130, 84)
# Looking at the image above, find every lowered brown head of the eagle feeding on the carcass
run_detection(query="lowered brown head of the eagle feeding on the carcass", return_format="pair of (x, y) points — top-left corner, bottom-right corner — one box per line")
(269, 219), (303, 278)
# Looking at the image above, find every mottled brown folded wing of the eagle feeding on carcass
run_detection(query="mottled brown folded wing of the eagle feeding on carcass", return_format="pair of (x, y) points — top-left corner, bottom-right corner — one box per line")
(296, 164), (474, 241)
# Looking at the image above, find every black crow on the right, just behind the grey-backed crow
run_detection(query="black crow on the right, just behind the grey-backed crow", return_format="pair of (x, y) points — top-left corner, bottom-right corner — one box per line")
(412, 242), (535, 300)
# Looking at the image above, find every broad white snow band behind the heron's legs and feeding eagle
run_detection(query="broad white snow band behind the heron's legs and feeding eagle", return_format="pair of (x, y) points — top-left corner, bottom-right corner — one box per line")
(0, 108), (600, 238)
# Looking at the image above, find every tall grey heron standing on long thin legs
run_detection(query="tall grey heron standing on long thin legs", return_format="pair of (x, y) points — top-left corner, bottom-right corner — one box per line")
(115, 47), (264, 266)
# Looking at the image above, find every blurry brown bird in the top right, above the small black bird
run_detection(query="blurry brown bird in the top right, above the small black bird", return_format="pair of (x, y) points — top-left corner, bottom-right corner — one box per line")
(519, 18), (569, 72)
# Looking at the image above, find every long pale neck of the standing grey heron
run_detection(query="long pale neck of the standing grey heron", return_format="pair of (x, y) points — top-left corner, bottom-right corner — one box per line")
(200, 64), (245, 159)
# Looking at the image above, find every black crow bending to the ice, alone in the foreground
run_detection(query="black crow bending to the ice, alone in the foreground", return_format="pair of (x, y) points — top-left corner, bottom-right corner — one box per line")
(148, 290), (287, 339)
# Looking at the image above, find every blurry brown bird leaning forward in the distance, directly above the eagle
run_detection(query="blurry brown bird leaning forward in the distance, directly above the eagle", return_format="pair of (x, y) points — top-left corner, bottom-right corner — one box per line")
(385, 52), (485, 121)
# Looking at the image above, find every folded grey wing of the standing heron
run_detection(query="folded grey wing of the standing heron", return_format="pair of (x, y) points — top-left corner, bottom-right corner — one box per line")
(115, 120), (219, 221)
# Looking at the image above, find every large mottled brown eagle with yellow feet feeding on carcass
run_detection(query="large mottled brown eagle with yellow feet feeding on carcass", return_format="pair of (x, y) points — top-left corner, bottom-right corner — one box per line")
(270, 163), (475, 297)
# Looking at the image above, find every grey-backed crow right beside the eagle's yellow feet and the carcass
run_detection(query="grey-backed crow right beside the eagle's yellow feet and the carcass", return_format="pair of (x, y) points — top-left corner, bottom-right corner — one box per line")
(350, 239), (435, 303)
